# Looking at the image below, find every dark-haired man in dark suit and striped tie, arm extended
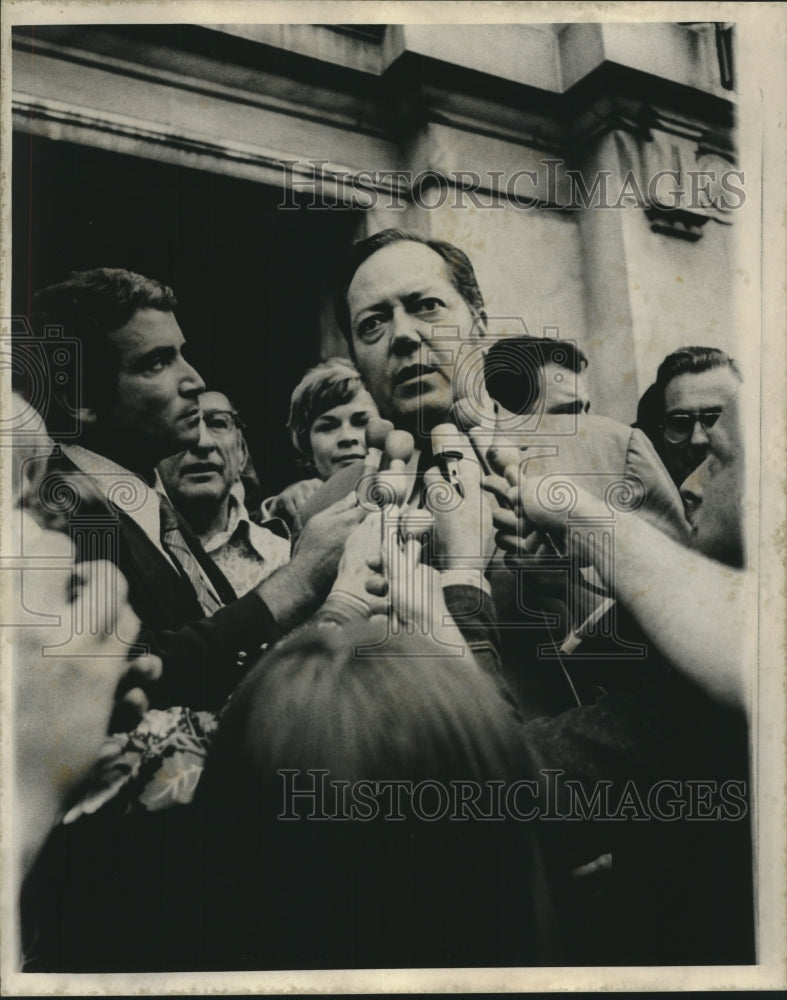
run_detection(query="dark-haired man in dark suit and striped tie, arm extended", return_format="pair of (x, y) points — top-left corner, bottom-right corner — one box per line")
(28, 268), (364, 710)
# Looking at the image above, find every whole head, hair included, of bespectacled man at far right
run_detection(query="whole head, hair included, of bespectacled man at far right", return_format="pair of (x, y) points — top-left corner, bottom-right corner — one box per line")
(635, 347), (742, 494)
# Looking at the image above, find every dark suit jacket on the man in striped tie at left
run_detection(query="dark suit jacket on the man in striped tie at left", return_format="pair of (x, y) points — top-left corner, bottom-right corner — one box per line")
(41, 449), (279, 710)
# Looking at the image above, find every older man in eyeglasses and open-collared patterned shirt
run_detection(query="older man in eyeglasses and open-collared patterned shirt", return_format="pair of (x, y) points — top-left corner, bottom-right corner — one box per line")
(158, 390), (290, 597)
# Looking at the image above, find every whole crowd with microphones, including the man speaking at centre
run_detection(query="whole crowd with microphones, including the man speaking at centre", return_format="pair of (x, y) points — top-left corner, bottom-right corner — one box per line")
(12, 230), (754, 972)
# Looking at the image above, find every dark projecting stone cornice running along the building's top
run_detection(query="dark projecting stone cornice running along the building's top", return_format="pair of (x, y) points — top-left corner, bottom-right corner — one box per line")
(14, 25), (734, 159)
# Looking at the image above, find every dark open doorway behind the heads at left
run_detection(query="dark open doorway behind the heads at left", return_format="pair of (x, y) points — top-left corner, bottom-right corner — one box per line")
(13, 133), (359, 494)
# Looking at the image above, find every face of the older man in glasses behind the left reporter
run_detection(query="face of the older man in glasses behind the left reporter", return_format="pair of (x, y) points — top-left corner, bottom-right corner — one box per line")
(158, 392), (247, 506)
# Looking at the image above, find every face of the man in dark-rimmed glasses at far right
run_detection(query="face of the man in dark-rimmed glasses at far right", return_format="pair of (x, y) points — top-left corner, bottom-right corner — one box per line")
(661, 366), (740, 486)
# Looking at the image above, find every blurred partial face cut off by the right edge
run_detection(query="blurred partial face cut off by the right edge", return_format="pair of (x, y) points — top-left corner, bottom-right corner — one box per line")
(681, 396), (744, 567)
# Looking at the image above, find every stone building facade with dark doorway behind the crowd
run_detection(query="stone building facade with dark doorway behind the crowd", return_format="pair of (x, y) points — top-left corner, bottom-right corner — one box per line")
(13, 22), (746, 478)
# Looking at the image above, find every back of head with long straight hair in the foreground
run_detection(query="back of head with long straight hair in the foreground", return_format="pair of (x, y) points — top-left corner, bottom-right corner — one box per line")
(201, 625), (556, 968)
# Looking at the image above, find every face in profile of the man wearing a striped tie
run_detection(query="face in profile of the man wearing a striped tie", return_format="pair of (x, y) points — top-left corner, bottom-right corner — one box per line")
(99, 309), (205, 465)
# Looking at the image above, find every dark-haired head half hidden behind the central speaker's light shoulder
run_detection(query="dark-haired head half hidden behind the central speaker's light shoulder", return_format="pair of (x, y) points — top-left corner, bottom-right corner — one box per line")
(484, 336), (590, 414)
